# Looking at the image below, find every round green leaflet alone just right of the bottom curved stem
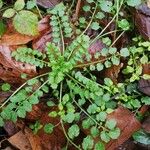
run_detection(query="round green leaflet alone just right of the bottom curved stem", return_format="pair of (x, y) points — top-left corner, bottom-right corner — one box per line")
(68, 124), (80, 139)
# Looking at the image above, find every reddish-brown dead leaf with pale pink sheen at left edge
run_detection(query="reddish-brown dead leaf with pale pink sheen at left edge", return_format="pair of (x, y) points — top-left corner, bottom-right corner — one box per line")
(0, 45), (36, 84)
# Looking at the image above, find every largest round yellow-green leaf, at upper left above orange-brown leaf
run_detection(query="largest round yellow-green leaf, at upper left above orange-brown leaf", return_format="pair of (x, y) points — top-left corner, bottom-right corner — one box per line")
(13, 10), (38, 36)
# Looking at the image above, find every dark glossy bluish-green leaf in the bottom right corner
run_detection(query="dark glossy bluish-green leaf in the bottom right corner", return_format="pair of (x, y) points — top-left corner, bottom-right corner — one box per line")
(133, 130), (150, 145)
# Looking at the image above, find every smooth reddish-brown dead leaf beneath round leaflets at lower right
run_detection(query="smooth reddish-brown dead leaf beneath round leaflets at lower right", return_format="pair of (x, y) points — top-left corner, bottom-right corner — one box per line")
(106, 106), (141, 150)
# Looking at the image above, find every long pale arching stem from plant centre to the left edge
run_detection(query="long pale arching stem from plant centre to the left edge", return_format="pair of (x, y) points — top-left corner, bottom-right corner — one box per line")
(0, 73), (49, 108)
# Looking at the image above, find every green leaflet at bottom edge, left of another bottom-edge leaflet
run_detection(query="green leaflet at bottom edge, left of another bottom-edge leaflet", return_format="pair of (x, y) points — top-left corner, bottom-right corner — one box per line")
(82, 136), (94, 150)
